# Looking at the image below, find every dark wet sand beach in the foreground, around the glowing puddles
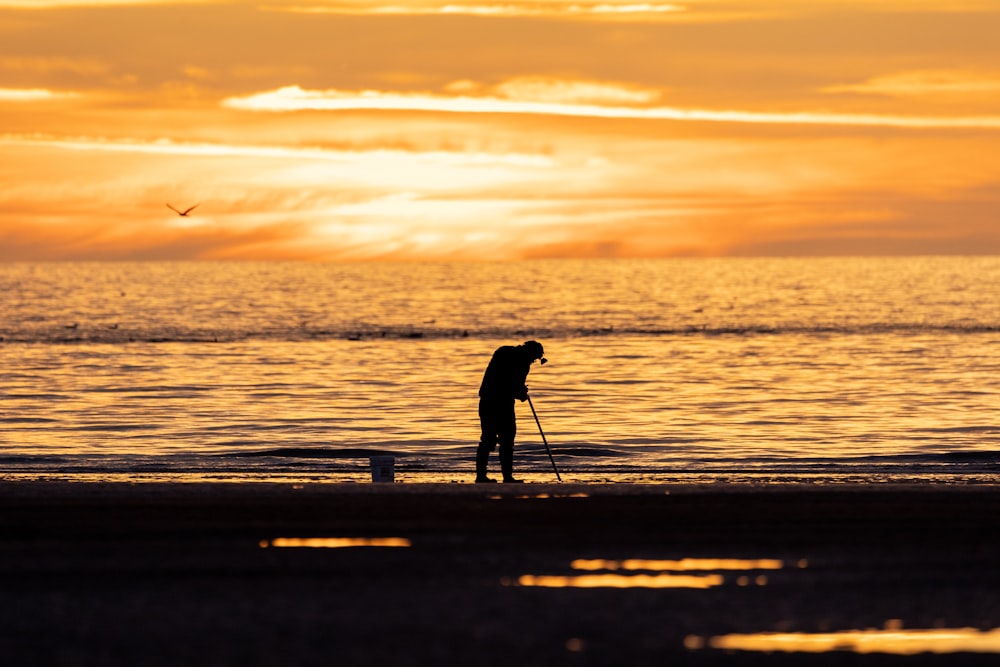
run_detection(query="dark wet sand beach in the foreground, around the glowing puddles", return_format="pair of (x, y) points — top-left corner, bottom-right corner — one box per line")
(0, 482), (1000, 667)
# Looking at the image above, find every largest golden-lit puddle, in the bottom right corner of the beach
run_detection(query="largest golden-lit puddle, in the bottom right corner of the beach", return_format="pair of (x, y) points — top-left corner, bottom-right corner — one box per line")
(700, 628), (1000, 655)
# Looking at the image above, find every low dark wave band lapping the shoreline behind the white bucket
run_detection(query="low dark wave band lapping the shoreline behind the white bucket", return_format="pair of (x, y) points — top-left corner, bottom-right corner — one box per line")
(0, 443), (1000, 481)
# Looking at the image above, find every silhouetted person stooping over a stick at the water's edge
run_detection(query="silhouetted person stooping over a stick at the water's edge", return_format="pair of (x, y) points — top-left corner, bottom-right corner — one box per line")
(476, 340), (546, 484)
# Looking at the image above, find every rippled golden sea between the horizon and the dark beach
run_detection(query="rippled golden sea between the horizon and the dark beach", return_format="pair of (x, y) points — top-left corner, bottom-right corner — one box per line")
(0, 257), (1000, 483)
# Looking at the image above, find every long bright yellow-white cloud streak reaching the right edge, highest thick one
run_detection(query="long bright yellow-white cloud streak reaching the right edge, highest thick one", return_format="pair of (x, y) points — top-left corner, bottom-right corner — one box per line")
(223, 86), (1000, 129)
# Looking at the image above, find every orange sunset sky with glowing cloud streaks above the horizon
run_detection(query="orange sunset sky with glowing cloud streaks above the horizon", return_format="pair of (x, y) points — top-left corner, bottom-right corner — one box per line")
(0, 0), (1000, 261)
